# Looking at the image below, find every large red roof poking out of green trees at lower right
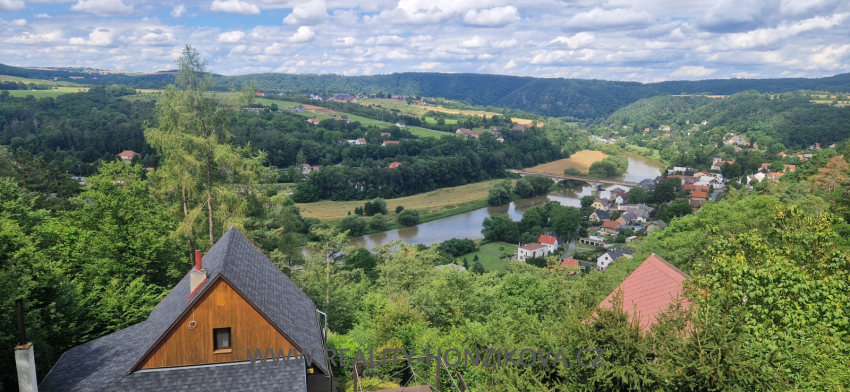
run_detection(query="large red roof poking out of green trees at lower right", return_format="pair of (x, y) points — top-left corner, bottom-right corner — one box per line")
(599, 253), (691, 328)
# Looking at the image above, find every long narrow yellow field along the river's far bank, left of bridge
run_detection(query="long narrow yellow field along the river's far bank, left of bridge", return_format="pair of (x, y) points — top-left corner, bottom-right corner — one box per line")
(296, 180), (503, 222)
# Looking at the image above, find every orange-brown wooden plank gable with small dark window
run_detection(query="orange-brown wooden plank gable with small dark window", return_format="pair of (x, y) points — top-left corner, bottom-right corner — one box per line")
(137, 279), (300, 369)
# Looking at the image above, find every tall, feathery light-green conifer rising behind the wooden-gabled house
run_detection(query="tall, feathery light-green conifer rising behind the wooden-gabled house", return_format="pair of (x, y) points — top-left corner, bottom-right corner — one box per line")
(145, 45), (269, 246)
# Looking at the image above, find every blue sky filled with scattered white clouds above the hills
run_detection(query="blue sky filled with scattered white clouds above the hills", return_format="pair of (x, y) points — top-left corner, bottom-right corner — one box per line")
(0, 0), (850, 82)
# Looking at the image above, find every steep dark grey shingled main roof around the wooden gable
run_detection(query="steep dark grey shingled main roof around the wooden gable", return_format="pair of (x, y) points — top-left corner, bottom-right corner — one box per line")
(38, 227), (328, 392)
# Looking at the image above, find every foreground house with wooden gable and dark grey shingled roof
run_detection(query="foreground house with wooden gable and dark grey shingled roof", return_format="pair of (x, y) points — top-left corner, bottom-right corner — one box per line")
(33, 227), (336, 392)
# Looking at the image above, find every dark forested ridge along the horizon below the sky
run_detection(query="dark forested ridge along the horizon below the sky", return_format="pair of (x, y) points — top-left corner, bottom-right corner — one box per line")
(0, 64), (850, 121)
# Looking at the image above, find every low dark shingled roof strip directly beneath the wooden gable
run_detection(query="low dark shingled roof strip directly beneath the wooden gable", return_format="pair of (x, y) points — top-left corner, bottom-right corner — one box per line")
(106, 362), (307, 392)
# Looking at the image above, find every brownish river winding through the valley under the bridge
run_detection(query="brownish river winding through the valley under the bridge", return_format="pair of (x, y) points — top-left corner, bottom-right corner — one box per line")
(322, 153), (664, 249)
